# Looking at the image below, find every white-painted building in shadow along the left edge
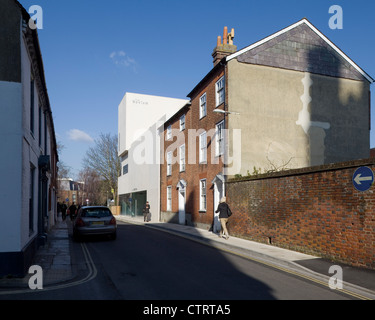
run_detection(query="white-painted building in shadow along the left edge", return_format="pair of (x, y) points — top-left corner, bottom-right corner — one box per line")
(0, 0), (58, 276)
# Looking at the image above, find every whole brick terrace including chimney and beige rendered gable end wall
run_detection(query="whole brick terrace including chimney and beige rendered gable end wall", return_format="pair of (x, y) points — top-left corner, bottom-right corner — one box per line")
(160, 19), (374, 231)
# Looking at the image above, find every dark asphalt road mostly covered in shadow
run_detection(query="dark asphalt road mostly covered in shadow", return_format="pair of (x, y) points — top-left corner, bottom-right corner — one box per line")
(2, 222), (354, 304)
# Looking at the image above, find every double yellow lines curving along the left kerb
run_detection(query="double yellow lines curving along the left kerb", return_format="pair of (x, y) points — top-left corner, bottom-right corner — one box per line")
(0, 243), (98, 295)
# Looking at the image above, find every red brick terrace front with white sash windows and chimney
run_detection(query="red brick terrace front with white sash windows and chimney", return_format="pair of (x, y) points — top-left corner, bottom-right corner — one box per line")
(160, 28), (237, 231)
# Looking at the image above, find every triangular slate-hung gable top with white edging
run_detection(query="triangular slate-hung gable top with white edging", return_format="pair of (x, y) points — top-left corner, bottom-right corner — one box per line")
(233, 22), (373, 83)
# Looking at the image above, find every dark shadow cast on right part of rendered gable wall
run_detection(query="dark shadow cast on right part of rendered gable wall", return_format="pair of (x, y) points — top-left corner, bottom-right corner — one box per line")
(306, 43), (370, 166)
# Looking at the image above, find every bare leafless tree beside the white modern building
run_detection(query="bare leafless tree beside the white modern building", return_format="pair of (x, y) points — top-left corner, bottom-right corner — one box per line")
(83, 133), (121, 204)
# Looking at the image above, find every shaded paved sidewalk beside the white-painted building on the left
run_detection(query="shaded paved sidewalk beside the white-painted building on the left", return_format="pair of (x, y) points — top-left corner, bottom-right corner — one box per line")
(0, 217), (74, 290)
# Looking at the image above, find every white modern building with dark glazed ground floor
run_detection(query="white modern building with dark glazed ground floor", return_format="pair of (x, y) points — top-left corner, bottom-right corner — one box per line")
(118, 93), (189, 221)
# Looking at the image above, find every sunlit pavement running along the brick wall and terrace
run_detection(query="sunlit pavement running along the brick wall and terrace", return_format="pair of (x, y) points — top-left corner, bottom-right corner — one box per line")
(116, 216), (375, 299)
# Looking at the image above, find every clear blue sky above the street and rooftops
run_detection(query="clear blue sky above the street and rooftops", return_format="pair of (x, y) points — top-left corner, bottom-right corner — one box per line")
(19, 0), (375, 177)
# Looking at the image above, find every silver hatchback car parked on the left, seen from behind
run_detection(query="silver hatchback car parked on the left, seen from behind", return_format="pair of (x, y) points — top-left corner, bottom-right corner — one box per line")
(73, 206), (117, 239)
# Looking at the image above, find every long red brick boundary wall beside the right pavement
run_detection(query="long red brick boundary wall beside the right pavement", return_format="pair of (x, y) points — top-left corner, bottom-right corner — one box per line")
(227, 159), (375, 269)
